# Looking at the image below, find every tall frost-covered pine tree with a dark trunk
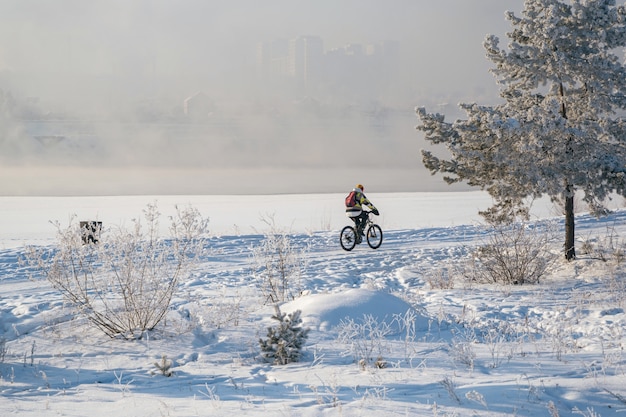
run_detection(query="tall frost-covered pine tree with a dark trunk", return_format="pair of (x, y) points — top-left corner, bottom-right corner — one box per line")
(417, 0), (626, 260)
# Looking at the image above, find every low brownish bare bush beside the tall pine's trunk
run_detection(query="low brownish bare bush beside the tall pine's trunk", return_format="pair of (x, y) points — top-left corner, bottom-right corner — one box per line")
(466, 223), (558, 285)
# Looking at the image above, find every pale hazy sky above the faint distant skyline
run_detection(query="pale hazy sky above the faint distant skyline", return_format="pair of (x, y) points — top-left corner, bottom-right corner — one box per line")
(0, 0), (522, 100)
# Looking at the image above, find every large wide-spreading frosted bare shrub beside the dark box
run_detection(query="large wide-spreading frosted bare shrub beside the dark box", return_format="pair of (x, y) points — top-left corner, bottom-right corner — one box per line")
(26, 205), (208, 339)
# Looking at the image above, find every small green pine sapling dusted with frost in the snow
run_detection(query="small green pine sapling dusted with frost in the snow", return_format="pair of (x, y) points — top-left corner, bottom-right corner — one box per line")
(259, 306), (309, 365)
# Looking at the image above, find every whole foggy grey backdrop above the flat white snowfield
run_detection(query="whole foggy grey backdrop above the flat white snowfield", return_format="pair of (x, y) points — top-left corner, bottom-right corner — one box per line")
(0, 0), (523, 195)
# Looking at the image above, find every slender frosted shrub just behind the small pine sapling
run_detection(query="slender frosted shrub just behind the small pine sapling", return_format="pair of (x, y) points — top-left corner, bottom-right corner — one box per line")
(252, 221), (304, 304)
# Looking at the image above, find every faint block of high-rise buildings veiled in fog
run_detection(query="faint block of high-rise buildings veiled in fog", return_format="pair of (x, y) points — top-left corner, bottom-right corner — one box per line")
(256, 36), (406, 102)
